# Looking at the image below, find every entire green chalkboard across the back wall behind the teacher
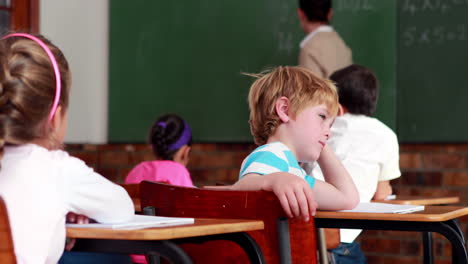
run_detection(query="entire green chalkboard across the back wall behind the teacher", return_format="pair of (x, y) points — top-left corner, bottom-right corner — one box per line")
(109, 0), (468, 142)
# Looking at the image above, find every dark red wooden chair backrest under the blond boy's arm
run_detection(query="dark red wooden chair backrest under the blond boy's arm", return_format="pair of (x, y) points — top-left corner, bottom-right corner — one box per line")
(140, 181), (317, 263)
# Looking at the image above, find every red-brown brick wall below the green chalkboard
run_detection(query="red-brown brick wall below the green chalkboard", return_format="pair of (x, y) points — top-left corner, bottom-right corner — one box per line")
(67, 143), (468, 264)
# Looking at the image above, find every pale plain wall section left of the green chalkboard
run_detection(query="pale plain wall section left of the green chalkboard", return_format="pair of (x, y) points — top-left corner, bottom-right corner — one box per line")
(39, 0), (109, 143)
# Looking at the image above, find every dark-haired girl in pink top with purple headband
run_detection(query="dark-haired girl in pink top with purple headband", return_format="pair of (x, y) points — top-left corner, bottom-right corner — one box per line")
(125, 114), (193, 263)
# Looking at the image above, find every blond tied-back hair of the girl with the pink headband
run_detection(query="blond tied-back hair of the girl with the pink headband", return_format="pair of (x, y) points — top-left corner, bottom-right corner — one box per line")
(0, 35), (71, 158)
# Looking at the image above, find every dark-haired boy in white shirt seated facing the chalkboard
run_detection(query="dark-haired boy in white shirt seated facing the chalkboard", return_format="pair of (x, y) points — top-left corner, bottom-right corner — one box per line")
(311, 64), (401, 263)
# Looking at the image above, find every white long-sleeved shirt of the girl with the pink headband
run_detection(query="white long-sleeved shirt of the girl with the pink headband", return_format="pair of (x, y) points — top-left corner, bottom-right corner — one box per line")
(0, 144), (134, 264)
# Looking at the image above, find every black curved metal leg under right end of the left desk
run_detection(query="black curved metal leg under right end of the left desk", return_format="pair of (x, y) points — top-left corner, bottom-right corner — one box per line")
(175, 232), (265, 264)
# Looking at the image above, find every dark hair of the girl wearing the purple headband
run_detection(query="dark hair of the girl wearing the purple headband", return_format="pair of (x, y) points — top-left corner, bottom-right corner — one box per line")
(149, 114), (192, 160)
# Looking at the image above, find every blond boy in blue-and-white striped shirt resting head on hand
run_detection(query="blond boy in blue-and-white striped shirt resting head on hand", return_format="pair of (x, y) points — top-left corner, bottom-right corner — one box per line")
(223, 66), (359, 221)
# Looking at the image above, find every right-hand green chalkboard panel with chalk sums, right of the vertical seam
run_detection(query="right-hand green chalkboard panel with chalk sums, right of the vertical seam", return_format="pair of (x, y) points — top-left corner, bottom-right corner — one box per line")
(397, 0), (468, 142)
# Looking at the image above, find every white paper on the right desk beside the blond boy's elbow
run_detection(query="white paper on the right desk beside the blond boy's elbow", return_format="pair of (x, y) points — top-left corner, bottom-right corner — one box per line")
(339, 203), (424, 214)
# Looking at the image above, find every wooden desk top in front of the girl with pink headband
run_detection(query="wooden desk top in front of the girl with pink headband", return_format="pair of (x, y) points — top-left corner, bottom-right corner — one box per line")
(67, 218), (264, 240)
